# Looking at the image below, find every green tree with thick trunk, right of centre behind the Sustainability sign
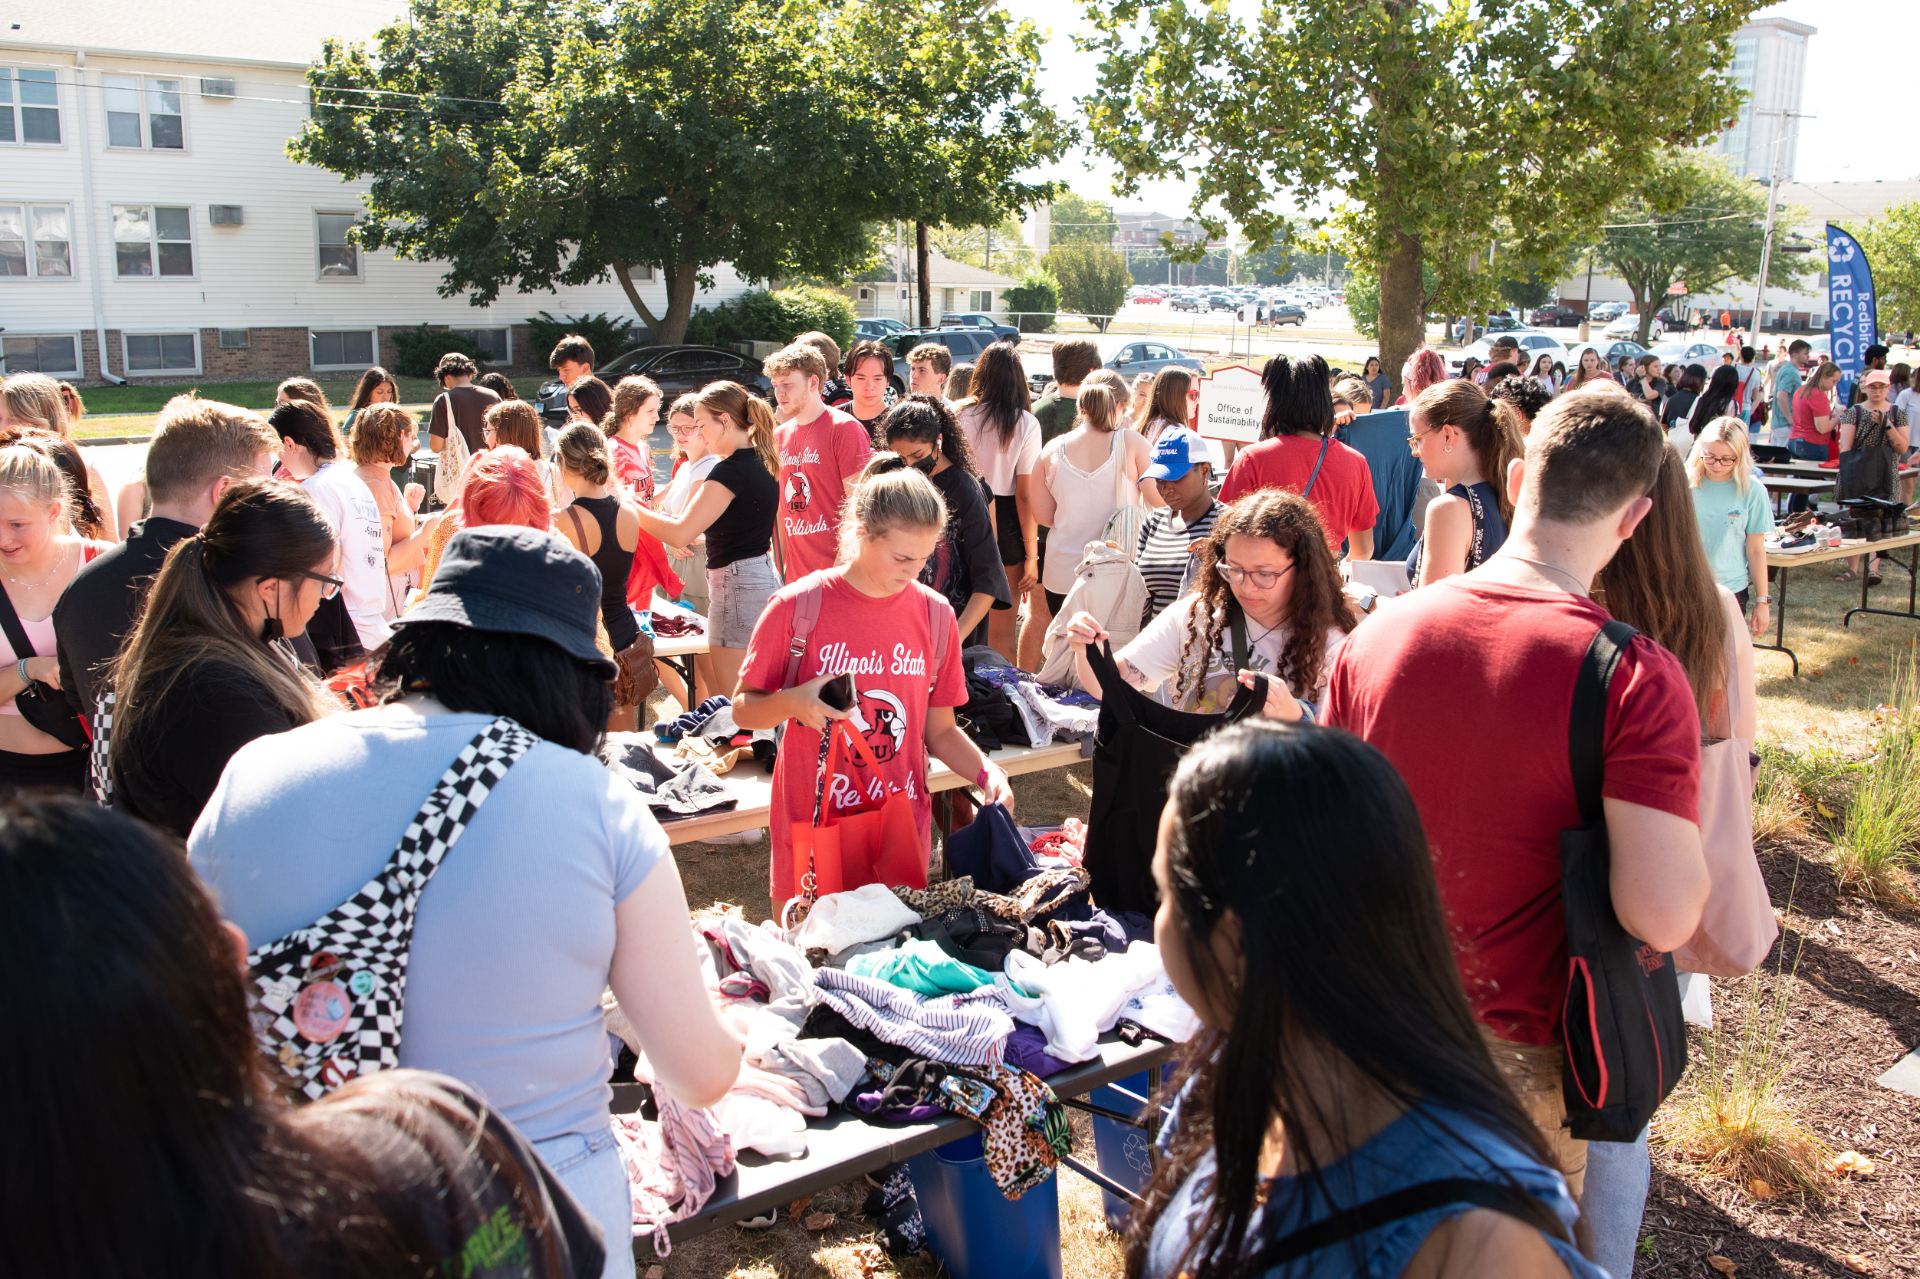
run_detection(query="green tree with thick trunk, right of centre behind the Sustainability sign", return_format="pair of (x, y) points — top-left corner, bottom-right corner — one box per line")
(1083, 0), (1757, 387)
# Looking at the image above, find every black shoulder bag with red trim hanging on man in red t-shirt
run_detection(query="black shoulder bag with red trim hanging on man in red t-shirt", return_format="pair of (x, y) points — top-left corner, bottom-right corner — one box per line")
(1561, 622), (1686, 1141)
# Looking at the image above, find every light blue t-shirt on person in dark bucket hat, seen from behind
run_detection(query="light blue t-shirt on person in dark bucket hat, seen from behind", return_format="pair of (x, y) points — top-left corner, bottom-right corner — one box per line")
(186, 699), (668, 1141)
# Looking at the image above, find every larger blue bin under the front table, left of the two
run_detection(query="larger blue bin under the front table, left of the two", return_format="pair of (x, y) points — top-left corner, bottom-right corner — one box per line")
(906, 1133), (1060, 1279)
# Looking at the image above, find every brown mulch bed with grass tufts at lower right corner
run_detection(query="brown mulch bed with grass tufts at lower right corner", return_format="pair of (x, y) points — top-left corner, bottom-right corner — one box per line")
(1634, 837), (1920, 1277)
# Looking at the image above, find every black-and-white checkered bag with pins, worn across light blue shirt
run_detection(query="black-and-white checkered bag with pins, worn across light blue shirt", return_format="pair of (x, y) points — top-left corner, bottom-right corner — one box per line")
(248, 718), (536, 1098)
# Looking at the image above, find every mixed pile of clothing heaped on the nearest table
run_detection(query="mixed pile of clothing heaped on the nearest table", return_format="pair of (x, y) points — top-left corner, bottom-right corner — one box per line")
(609, 805), (1198, 1250)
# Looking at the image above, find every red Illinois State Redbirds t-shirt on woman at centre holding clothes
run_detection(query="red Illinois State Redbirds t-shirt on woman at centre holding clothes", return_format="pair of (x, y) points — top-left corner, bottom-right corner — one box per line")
(739, 568), (966, 910)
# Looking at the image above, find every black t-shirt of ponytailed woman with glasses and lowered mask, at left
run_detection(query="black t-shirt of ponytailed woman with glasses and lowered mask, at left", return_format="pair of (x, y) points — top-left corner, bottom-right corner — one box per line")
(113, 661), (294, 839)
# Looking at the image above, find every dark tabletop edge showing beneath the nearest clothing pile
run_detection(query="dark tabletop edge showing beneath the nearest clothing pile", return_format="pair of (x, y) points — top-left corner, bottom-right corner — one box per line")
(612, 1035), (1179, 1236)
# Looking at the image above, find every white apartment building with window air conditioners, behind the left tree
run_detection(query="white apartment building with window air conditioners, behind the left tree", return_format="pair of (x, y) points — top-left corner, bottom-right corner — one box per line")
(0, 0), (747, 382)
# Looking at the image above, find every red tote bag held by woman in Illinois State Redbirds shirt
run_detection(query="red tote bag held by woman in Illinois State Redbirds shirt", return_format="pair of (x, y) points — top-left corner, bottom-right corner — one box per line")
(787, 720), (927, 903)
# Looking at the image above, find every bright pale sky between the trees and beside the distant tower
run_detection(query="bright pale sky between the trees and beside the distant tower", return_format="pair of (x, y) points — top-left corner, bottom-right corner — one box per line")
(1004, 0), (1920, 213)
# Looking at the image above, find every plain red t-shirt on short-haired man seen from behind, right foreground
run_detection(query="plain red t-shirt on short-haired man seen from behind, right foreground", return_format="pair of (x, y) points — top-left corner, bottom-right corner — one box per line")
(1321, 574), (1699, 1043)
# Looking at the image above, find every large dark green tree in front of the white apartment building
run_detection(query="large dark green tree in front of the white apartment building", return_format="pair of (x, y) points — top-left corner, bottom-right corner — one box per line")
(288, 0), (1058, 342)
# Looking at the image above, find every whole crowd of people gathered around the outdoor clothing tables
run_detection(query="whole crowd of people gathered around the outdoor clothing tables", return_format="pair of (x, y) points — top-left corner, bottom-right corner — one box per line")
(0, 307), (1858, 1279)
